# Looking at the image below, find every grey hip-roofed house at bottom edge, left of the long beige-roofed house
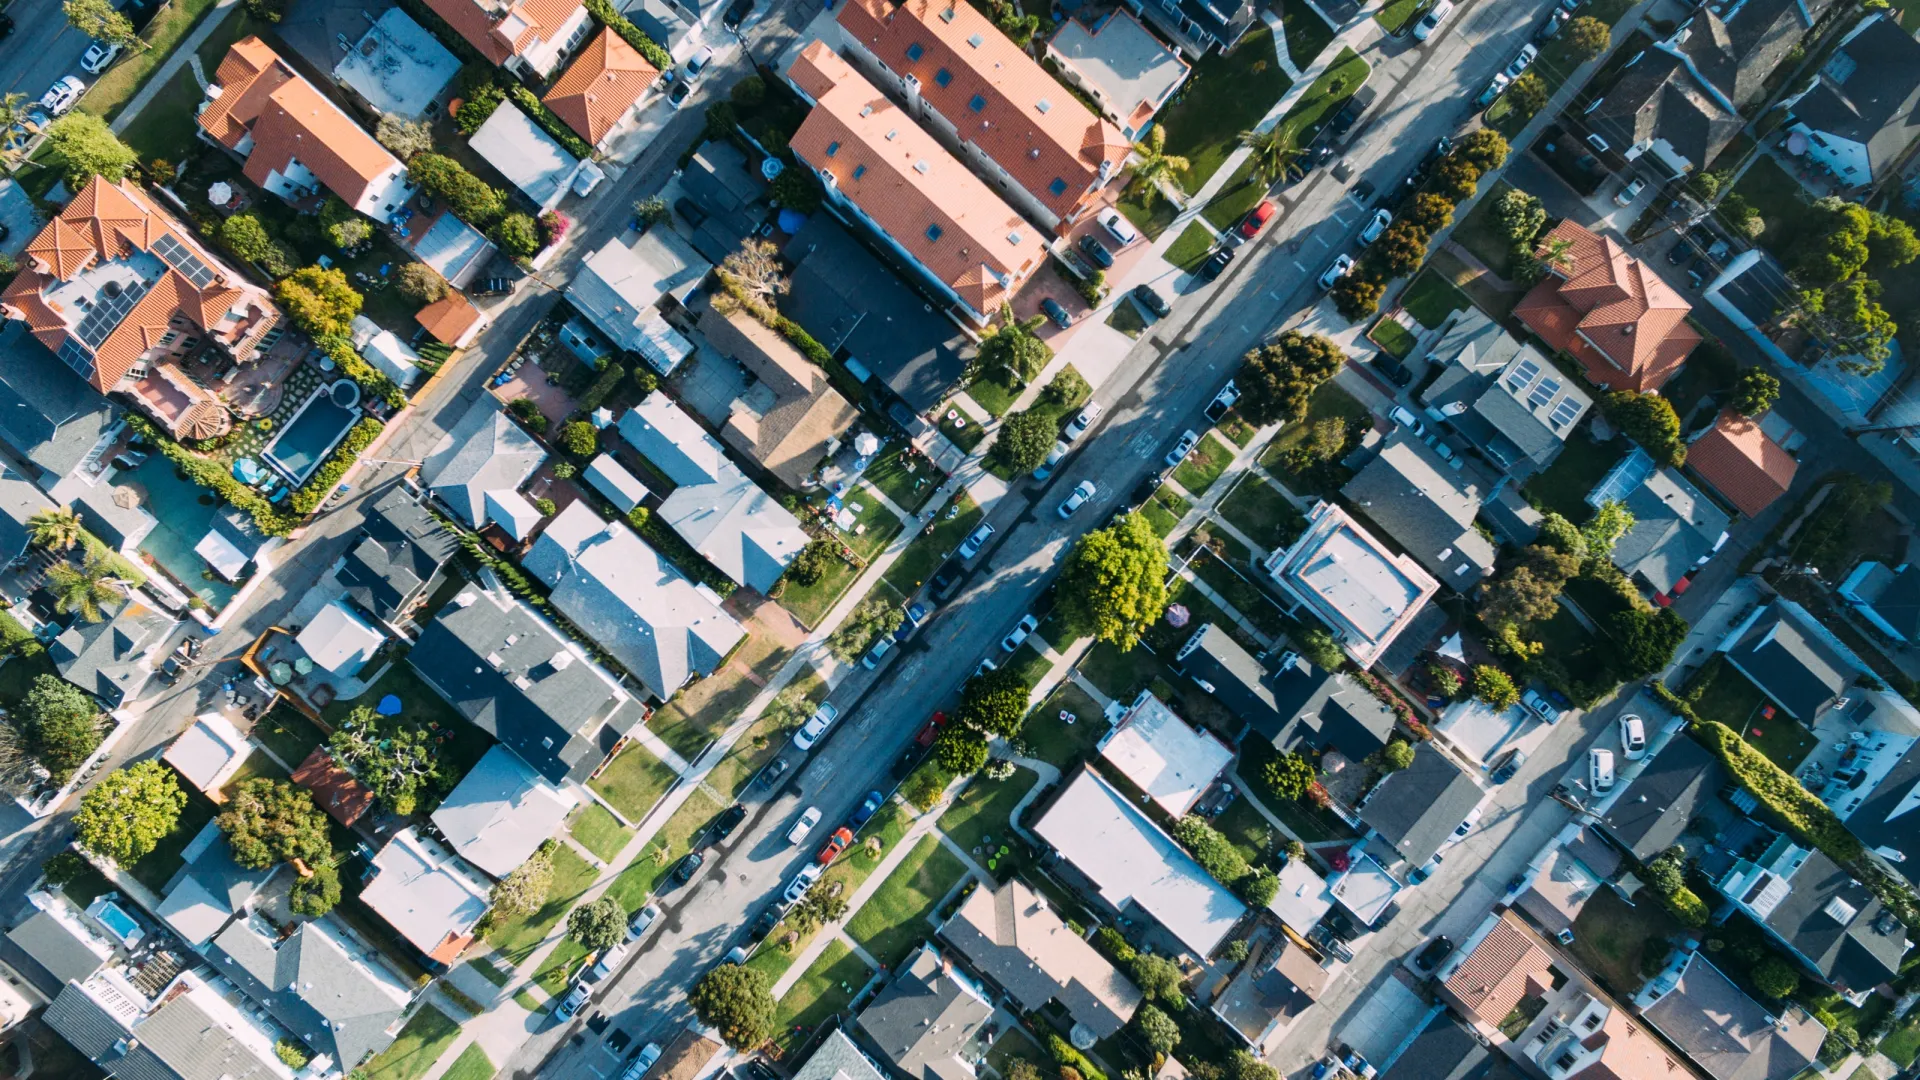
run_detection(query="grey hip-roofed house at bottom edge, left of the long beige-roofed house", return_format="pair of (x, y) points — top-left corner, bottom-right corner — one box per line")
(854, 945), (993, 1080)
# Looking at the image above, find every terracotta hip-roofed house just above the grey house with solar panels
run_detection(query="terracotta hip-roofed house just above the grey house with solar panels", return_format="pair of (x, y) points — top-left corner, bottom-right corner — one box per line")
(1513, 221), (1701, 390)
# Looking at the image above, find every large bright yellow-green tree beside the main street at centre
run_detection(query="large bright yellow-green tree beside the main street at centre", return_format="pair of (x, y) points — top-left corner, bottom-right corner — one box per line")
(1058, 511), (1167, 651)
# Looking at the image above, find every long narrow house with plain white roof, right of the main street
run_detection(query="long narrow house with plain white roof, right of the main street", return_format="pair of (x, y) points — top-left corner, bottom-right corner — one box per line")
(1033, 771), (1246, 957)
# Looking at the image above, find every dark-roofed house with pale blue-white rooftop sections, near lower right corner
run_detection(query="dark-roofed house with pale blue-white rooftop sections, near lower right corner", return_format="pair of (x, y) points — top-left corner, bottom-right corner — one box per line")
(1715, 836), (1910, 999)
